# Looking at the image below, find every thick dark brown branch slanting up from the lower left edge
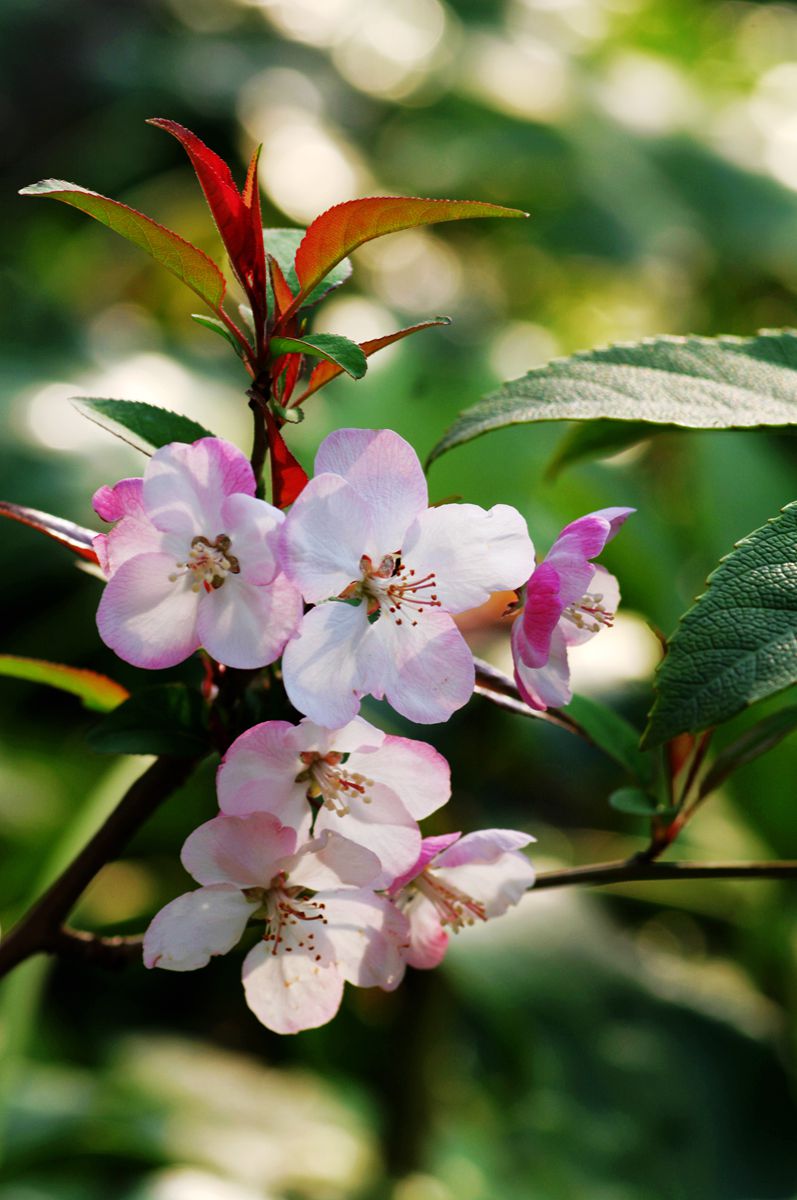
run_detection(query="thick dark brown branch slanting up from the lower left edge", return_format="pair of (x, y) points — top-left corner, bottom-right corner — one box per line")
(0, 757), (199, 977)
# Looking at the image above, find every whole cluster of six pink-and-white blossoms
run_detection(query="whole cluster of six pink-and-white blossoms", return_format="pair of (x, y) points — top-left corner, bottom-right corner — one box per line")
(94, 430), (630, 1033)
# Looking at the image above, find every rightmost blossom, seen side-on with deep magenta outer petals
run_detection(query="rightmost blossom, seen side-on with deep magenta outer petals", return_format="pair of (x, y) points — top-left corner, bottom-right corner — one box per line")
(513, 509), (634, 712)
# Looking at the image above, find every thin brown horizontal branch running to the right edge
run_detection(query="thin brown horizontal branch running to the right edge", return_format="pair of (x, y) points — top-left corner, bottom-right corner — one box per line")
(534, 858), (797, 892)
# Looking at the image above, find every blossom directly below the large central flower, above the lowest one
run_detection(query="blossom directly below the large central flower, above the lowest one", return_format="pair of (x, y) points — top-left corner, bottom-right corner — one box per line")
(217, 718), (451, 887)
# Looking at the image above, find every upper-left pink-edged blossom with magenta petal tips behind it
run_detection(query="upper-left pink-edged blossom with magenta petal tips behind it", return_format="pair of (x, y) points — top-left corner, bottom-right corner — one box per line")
(94, 438), (301, 667)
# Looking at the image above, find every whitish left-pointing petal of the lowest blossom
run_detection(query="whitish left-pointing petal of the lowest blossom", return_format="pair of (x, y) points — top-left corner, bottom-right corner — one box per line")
(144, 883), (259, 971)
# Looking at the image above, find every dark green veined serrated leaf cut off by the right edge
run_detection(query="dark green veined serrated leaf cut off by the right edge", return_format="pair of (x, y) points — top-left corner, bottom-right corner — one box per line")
(643, 503), (797, 745)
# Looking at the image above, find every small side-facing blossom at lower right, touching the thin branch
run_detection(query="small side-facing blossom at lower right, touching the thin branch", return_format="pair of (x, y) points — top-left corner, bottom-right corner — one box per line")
(390, 829), (534, 967)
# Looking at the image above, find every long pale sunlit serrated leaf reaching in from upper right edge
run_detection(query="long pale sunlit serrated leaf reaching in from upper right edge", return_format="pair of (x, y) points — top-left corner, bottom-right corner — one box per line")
(429, 330), (797, 462)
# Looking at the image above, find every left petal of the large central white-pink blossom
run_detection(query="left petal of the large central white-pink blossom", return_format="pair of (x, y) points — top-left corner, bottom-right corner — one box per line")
(280, 475), (378, 604)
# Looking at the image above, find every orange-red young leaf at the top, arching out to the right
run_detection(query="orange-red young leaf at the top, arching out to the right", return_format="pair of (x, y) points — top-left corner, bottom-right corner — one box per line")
(293, 196), (527, 308)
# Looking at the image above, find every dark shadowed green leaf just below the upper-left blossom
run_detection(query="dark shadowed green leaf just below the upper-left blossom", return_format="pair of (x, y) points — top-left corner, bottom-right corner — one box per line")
(86, 683), (208, 757)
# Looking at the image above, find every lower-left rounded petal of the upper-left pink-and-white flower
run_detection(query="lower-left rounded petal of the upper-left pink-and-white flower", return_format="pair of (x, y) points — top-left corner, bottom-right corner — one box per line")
(97, 554), (200, 668)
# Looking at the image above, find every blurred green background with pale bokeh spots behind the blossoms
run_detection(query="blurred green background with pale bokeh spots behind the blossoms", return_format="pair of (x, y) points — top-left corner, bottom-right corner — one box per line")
(0, 0), (797, 1200)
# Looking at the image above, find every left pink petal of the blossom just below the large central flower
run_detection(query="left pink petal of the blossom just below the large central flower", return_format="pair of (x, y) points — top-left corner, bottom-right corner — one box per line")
(216, 721), (307, 826)
